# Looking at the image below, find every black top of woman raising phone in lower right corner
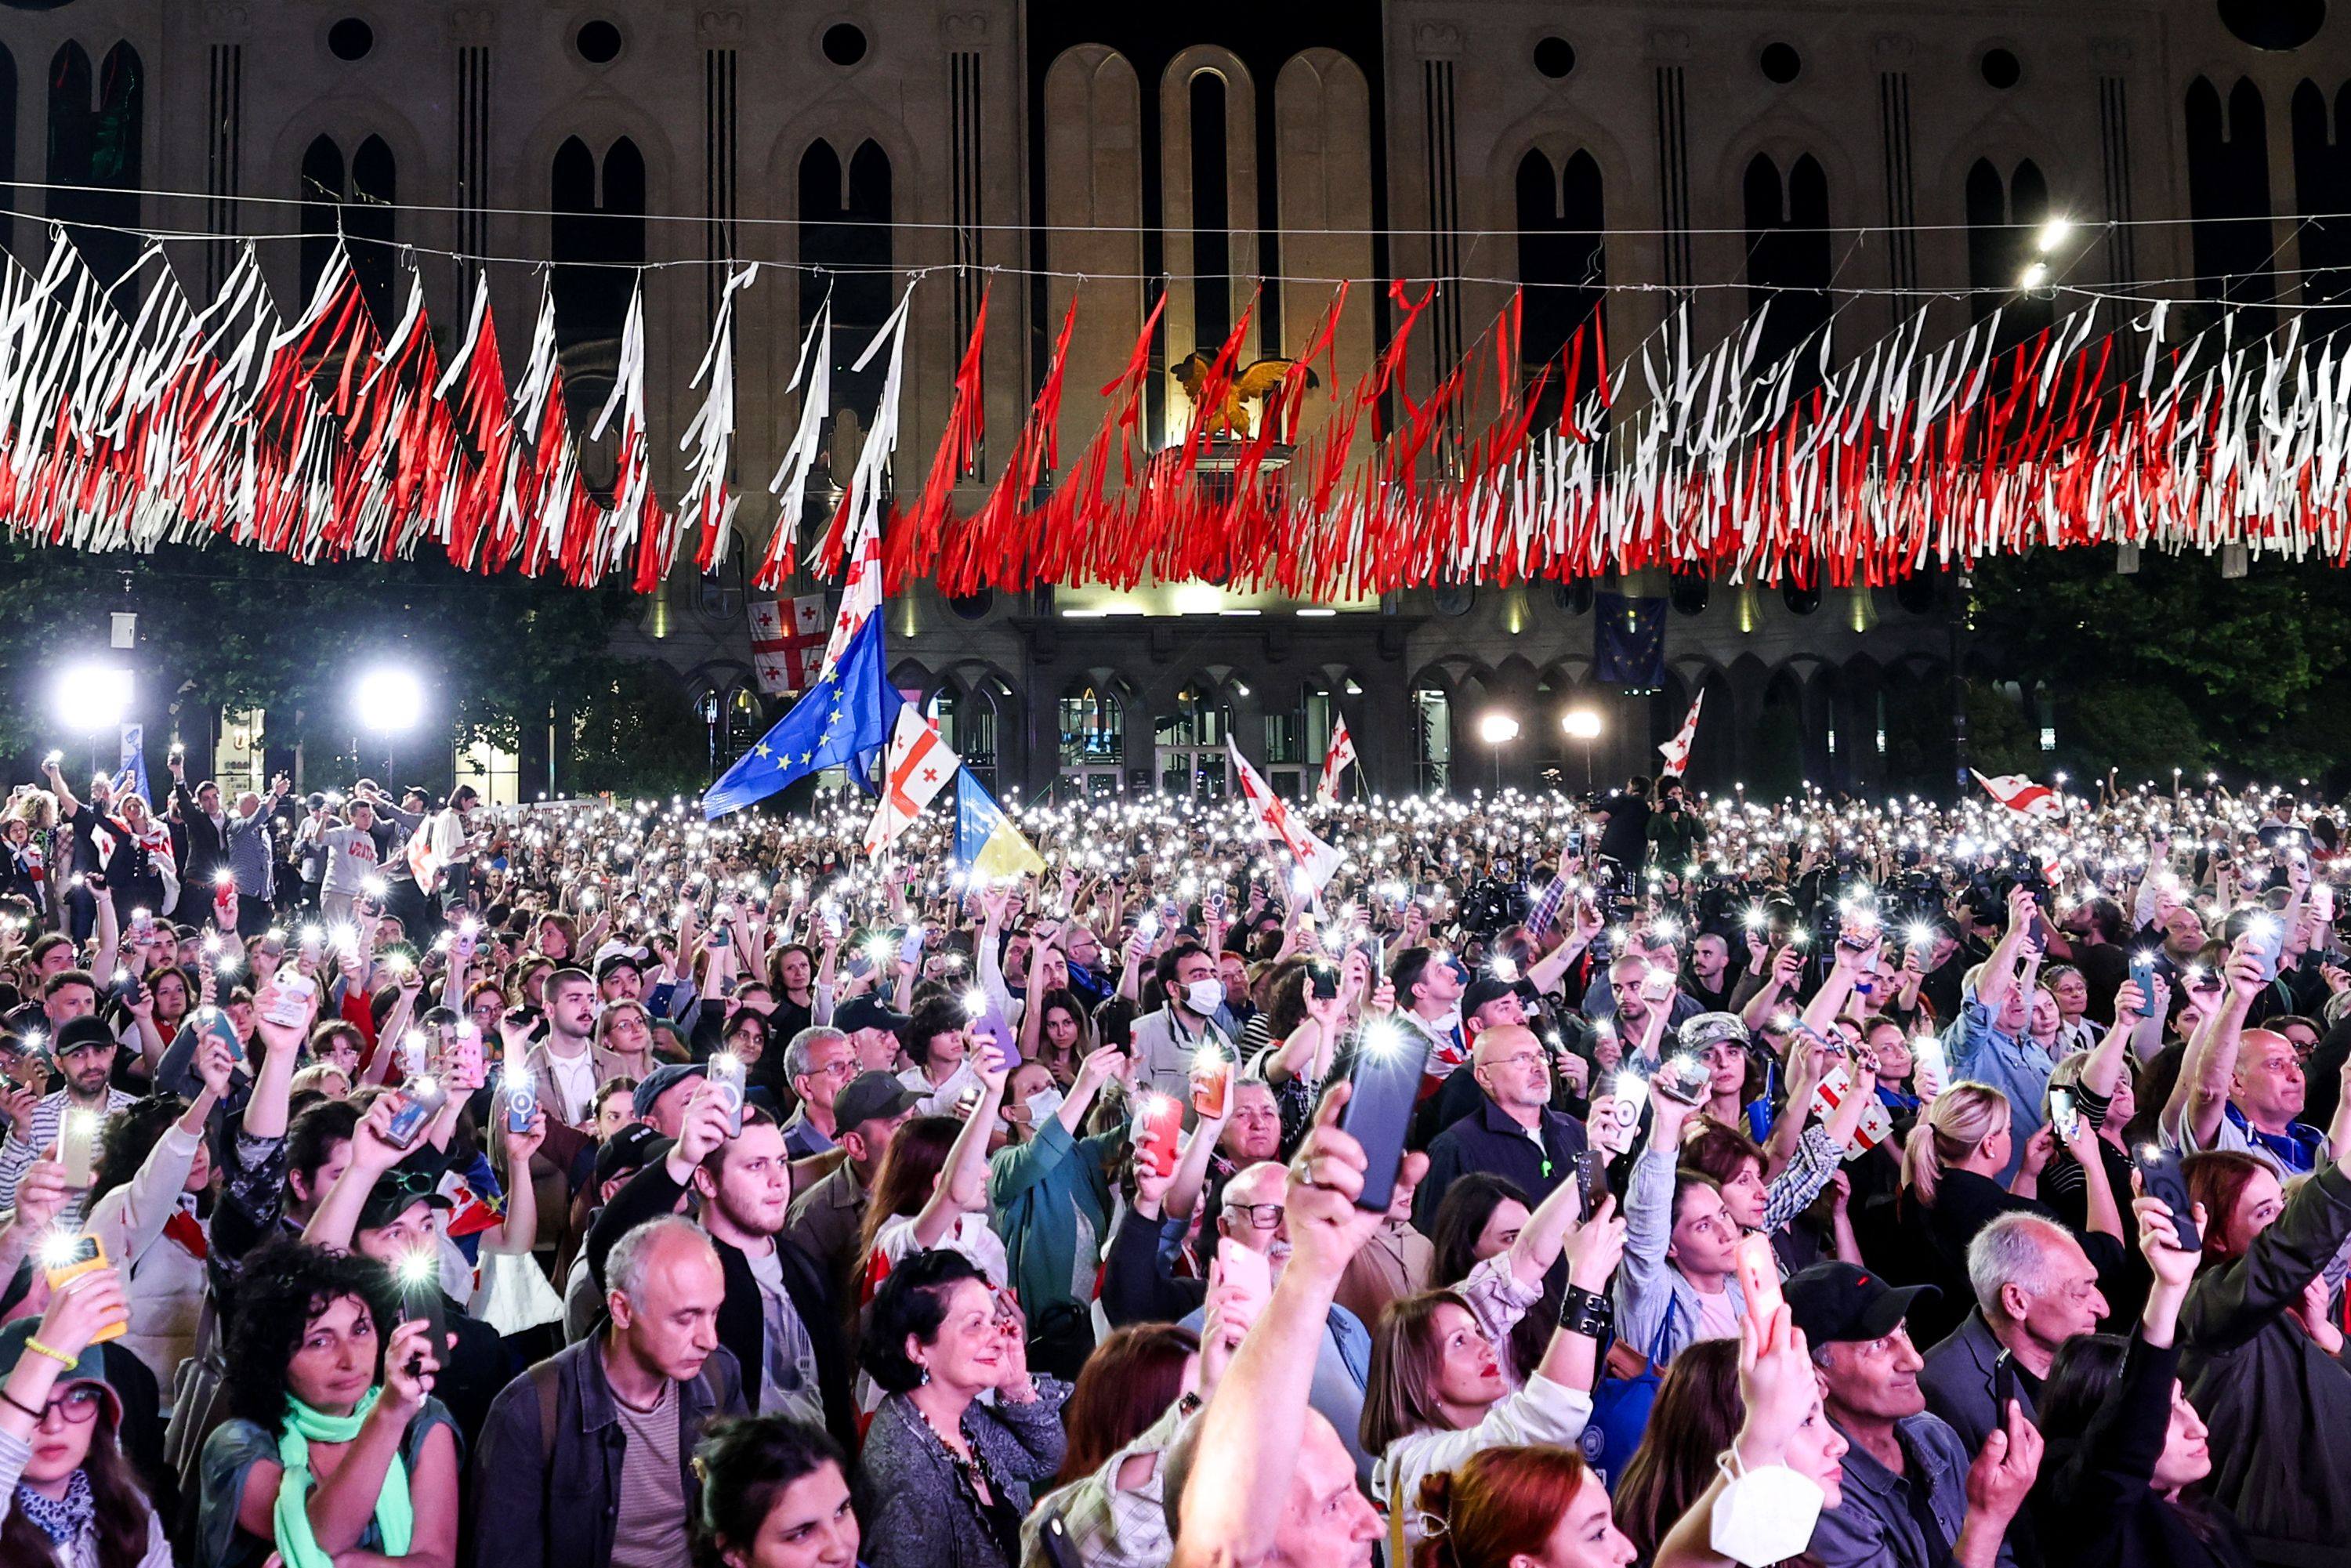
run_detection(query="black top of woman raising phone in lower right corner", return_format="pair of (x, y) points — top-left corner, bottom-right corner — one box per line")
(2031, 1335), (2252, 1568)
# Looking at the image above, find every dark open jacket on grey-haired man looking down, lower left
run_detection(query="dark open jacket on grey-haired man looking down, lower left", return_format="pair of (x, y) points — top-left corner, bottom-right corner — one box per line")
(473, 1335), (743, 1568)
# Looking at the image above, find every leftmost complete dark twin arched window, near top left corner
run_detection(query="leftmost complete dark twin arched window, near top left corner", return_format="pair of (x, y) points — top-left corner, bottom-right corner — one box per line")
(49, 42), (146, 297)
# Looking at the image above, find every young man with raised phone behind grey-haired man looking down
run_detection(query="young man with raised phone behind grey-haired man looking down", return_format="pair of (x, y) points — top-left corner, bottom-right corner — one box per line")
(588, 1081), (858, 1448)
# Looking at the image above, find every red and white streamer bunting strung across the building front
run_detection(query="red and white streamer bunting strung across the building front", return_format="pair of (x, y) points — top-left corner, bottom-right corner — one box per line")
(0, 233), (2351, 595)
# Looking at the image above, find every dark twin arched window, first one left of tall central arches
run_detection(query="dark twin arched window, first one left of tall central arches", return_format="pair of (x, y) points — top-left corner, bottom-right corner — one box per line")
(799, 139), (898, 416)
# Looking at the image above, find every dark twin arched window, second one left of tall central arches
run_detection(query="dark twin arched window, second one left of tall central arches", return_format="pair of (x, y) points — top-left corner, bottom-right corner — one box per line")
(548, 136), (644, 425)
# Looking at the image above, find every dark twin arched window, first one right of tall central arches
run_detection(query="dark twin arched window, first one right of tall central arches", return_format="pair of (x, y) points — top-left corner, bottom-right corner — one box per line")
(1519, 148), (1608, 425)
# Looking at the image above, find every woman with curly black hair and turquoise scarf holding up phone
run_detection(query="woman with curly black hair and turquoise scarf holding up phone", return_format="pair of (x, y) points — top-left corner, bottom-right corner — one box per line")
(197, 1241), (458, 1568)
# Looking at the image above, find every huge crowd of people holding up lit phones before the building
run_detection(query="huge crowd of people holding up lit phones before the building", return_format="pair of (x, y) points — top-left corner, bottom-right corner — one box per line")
(0, 752), (2351, 1568)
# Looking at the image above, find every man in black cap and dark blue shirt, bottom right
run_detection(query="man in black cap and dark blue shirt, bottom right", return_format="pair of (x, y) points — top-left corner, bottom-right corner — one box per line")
(1784, 1262), (2041, 1568)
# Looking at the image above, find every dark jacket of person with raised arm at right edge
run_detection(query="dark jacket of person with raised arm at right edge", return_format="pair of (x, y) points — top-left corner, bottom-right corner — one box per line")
(2179, 1166), (2351, 1563)
